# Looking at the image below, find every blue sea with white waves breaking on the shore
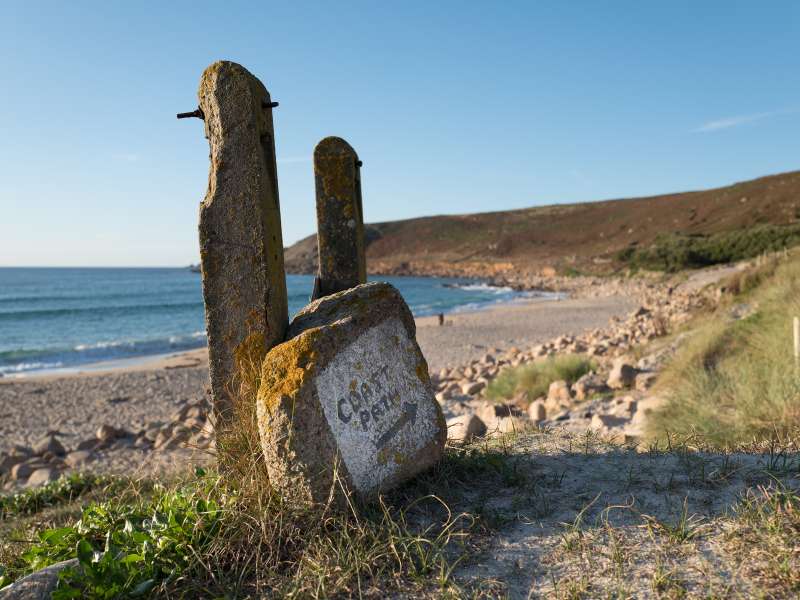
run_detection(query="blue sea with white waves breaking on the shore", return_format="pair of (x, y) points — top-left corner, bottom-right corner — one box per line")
(0, 268), (547, 377)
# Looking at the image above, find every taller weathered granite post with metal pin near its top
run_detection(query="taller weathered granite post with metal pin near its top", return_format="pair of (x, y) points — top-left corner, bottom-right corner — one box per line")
(198, 61), (288, 427)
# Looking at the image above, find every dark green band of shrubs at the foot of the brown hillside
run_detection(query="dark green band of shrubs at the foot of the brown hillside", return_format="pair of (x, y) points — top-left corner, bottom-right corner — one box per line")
(617, 225), (800, 273)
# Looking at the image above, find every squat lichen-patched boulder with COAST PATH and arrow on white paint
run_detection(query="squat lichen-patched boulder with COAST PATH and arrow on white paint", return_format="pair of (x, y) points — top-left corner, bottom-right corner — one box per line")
(257, 283), (447, 501)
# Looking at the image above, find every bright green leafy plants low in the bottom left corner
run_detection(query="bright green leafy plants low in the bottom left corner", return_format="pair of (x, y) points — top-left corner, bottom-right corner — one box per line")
(6, 478), (226, 599)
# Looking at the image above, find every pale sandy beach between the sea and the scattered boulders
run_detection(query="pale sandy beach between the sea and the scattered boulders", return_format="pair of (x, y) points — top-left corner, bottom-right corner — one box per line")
(0, 295), (635, 482)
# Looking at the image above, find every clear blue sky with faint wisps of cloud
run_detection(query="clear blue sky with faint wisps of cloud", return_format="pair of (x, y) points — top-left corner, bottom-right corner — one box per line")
(0, 0), (800, 266)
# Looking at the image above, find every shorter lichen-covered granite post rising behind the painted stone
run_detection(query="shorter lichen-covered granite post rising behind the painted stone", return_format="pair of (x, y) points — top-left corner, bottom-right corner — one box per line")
(312, 137), (367, 300)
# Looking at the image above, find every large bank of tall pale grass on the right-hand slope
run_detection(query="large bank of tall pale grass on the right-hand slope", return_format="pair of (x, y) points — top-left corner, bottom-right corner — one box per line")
(649, 257), (800, 447)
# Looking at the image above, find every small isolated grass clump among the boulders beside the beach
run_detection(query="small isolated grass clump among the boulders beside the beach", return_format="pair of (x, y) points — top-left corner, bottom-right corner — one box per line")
(486, 354), (594, 400)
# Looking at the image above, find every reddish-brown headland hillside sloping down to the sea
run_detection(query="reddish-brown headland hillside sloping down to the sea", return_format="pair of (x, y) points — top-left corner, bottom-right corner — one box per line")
(285, 171), (800, 276)
